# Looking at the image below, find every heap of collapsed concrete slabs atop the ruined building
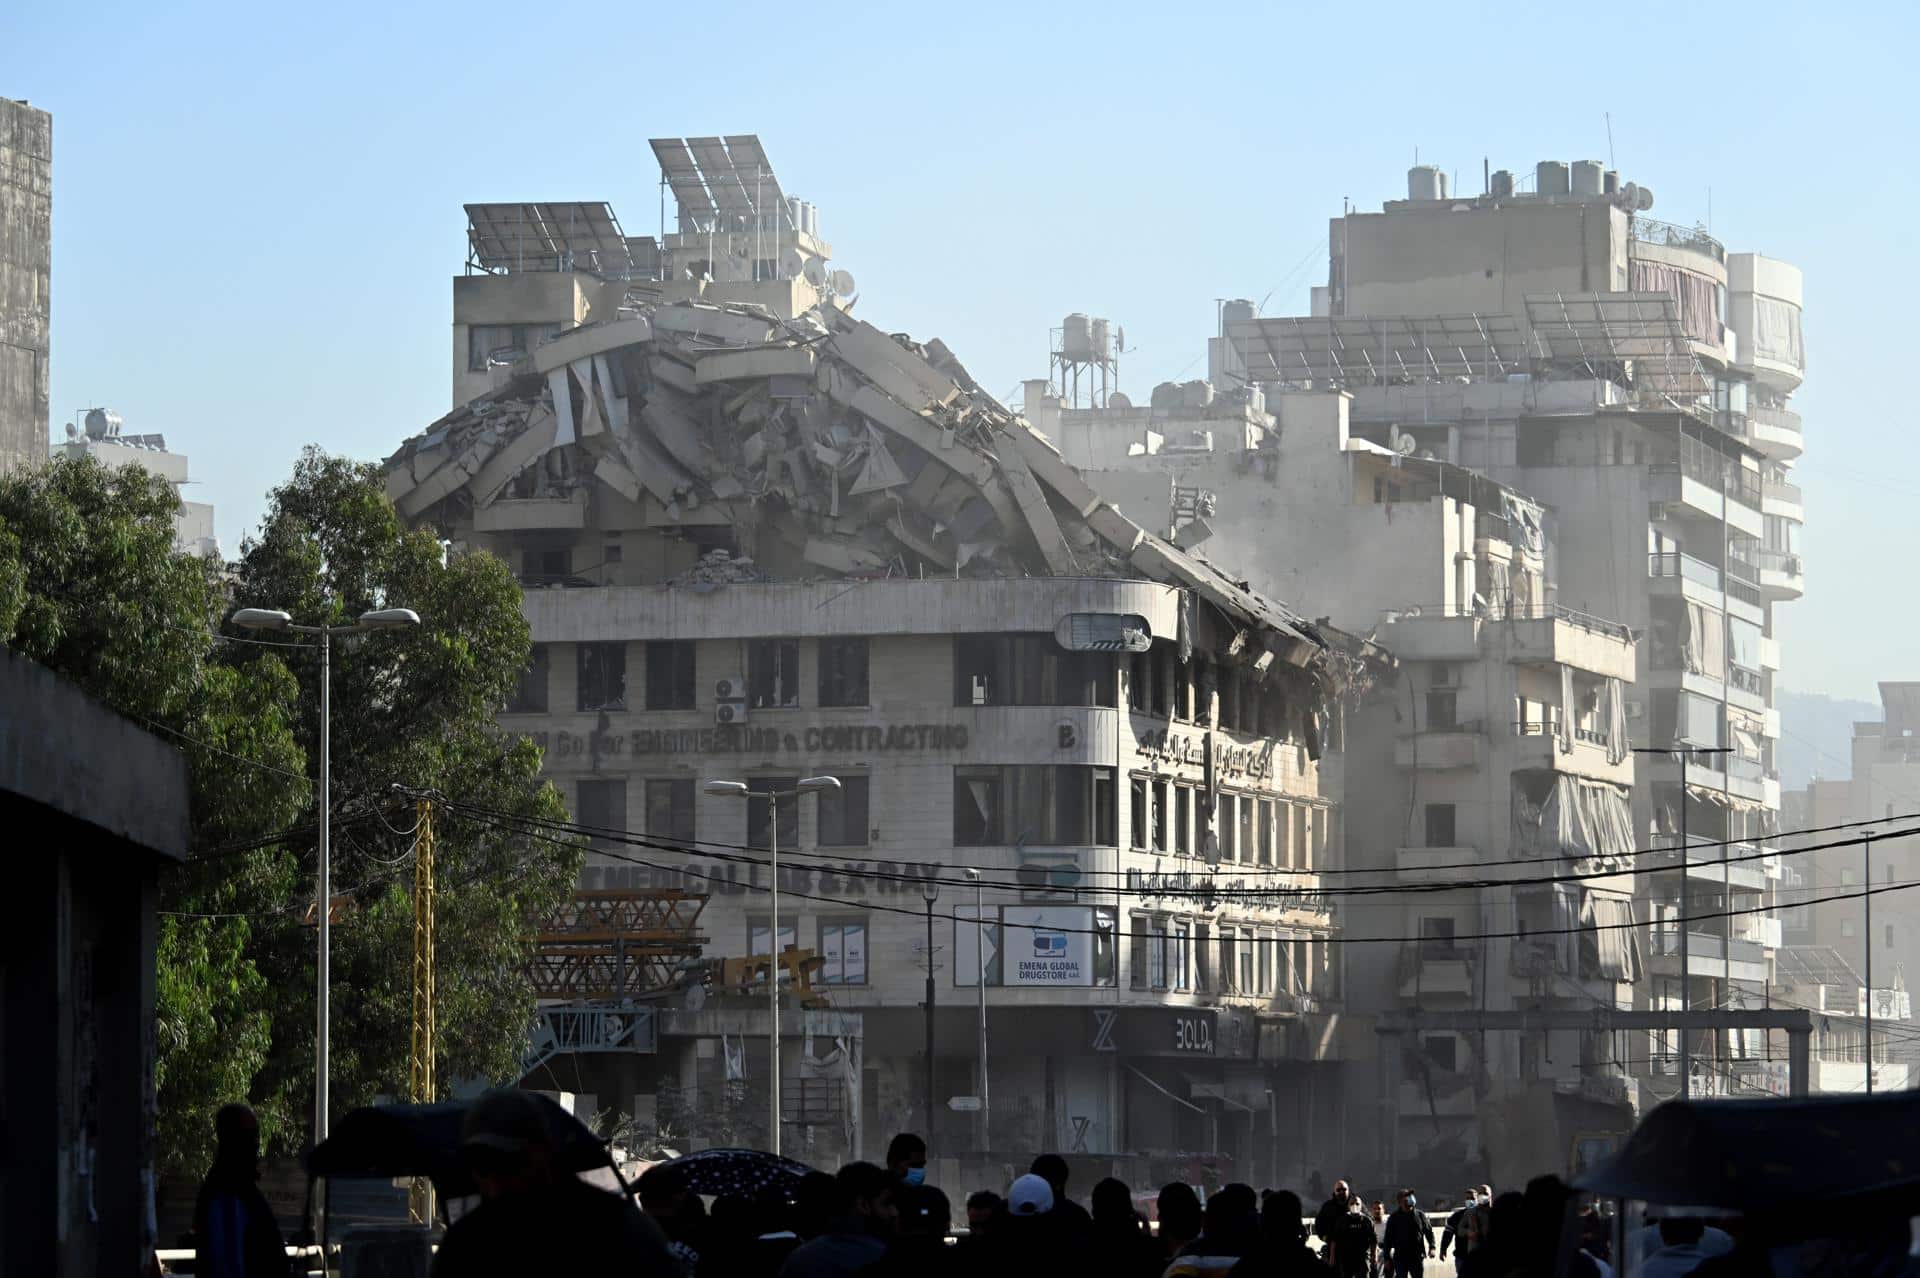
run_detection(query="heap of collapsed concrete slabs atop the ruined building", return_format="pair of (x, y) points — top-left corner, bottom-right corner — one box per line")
(386, 284), (1340, 672)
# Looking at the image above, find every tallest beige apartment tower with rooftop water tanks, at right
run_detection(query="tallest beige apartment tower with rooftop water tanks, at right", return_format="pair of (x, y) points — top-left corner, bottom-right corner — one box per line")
(1215, 161), (1805, 1096)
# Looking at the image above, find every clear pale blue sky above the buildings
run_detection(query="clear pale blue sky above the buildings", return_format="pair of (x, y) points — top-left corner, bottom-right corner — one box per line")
(0, 0), (1920, 697)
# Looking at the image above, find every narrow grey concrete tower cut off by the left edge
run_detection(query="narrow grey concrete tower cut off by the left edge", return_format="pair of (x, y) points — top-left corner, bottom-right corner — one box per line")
(0, 98), (54, 472)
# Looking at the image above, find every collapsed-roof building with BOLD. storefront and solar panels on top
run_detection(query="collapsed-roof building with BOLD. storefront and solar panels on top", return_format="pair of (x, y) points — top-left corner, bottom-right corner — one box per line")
(386, 138), (1377, 1180)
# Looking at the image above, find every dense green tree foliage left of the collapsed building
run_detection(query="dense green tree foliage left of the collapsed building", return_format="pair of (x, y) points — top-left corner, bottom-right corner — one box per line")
(0, 449), (580, 1171)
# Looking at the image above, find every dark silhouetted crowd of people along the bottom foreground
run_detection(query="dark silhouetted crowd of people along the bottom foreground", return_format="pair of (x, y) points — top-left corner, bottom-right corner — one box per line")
(180, 1090), (1745, 1278)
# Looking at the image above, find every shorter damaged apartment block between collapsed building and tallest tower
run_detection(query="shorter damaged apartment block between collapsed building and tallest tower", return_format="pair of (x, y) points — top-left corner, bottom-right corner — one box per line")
(1025, 379), (1645, 1180)
